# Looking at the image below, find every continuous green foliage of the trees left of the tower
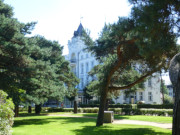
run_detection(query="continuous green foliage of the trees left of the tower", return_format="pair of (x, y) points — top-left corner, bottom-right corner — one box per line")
(0, 0), (78, 115)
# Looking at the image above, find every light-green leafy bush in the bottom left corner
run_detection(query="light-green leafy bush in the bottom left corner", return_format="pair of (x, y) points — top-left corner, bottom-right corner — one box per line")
(0, 90), (14, 135)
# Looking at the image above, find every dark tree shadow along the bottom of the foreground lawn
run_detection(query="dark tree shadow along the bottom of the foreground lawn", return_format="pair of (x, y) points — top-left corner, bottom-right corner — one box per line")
(74, 126), (171, 135)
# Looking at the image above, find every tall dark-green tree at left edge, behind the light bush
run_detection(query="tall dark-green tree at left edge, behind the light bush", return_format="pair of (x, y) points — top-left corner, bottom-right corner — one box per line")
(0, 0), (35, 116)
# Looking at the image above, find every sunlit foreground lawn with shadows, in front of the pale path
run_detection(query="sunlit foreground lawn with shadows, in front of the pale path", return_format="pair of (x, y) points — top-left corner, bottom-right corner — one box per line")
(13, 116), (171, 135)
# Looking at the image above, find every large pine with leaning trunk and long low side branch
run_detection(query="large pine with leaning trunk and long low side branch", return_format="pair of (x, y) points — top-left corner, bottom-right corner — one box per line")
(84, 0), (180, 126)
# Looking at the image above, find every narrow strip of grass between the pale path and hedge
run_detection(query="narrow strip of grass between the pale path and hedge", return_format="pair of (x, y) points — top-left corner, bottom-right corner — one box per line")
(44, 112), (172, 123)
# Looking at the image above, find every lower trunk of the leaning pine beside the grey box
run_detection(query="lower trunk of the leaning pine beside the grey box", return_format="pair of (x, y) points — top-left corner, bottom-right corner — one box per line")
(96, 88), (108, 127)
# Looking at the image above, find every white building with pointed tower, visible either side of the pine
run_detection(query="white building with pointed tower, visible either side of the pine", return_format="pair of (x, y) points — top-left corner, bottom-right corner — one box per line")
(66, 23), (162, 104)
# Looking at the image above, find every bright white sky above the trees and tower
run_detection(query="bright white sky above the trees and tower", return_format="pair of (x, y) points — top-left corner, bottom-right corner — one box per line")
(4, 0), (131, 54)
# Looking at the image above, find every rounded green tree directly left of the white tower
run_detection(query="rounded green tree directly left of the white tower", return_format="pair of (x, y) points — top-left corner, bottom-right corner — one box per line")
(24, 36), (78, 113)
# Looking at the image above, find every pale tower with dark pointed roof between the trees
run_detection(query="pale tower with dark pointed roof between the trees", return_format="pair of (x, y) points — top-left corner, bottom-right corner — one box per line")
(67, 23), (98, 104)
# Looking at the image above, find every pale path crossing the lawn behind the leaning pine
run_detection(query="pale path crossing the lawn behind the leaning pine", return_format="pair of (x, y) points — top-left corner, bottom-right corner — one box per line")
(48, 114), (172, 129)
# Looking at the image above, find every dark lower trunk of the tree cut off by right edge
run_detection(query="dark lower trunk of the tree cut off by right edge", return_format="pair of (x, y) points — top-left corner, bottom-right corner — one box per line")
(172, 81), (180, 135)
